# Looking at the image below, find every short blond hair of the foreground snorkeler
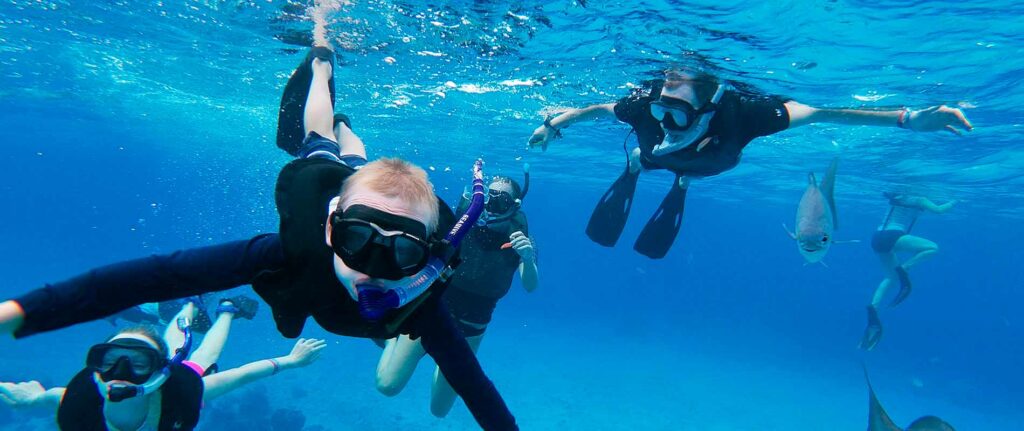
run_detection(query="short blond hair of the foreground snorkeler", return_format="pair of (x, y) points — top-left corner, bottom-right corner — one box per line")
(338, 159), (439, 234)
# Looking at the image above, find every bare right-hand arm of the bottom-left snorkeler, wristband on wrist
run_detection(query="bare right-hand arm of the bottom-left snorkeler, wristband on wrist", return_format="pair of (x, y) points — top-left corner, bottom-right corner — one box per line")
(203, 338), (327, 401)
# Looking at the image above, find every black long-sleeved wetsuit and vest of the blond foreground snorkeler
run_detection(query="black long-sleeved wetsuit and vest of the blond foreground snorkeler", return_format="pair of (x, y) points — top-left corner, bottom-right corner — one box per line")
(15, 159), (518, 430)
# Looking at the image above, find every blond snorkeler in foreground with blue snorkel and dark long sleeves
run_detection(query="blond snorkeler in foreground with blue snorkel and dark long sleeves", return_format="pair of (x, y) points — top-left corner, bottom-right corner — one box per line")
(0, 41), (518, 430)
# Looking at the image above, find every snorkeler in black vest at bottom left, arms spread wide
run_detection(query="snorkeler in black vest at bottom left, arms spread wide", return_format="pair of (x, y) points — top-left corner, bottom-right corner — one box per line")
(0, 303), (326, 431)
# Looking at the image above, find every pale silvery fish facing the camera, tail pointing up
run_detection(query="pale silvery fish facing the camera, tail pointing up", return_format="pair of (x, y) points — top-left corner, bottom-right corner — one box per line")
(782, 158), (856, 263)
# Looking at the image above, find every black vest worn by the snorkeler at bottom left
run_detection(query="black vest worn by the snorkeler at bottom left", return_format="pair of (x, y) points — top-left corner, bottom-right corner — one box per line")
(57, 364), (203, 431)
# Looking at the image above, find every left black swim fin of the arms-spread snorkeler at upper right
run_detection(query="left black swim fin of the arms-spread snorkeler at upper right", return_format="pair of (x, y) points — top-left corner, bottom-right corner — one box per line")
(587, 165), (640, 247)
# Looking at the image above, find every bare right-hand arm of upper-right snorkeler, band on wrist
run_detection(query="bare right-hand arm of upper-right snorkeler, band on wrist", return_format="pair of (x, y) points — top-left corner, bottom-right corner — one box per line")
(785, 100), (974, 135)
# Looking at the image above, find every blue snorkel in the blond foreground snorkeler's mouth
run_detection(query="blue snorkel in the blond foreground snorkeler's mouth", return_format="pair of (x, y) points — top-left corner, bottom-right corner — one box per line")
(355, 160), (484, 321)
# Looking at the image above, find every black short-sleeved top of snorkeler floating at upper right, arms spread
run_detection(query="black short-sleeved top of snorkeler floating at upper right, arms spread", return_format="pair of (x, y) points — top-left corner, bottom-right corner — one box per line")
(615, 80), (790, 177)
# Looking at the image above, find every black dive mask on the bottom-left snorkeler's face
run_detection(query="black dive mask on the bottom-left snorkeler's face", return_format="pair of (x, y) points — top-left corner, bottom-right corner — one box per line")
(85, 338), (167, 385)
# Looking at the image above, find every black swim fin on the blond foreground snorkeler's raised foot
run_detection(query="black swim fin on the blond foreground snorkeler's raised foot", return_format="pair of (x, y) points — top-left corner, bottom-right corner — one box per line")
(278, 46), (337, 156)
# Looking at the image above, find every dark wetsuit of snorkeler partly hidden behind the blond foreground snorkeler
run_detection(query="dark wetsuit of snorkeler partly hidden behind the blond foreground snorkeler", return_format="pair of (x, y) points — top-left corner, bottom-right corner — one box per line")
(444, 211), (529, 337)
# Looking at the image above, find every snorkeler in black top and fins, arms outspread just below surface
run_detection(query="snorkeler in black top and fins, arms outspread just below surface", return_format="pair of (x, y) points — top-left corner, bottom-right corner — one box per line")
(529, 70), (972, 259)
